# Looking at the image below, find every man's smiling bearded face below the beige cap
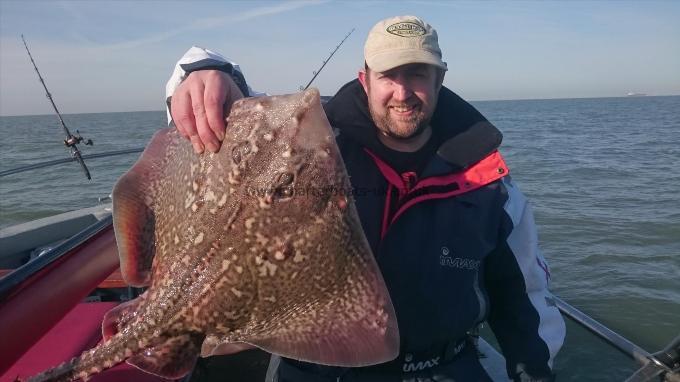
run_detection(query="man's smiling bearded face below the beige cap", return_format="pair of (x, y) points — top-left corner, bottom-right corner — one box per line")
(359, 64), (444, 138)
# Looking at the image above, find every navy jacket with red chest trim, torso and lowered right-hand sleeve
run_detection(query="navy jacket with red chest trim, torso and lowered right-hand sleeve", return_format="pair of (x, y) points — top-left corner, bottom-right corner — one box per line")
(316, 80), (565, 377)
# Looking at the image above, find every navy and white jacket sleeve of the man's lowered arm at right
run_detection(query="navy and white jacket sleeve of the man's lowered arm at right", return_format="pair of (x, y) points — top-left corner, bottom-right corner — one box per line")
(485, 177), (565, 381)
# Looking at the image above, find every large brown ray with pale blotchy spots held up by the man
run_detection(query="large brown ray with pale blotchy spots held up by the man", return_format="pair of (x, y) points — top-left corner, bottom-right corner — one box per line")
(30, 89), (399, 381)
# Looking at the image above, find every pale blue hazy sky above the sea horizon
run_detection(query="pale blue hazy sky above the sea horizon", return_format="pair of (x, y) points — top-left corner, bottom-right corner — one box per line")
(0, 0), (680, 116)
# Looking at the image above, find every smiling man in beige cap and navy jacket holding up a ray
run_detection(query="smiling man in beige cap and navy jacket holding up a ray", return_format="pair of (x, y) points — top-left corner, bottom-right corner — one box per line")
(167, 16), (565, 382)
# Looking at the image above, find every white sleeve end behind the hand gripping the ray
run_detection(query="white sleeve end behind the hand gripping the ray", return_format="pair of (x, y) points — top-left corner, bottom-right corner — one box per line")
(165, 46), (266, 124)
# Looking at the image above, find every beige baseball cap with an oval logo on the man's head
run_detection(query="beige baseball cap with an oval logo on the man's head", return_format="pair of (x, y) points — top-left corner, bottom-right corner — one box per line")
(364, 16), (447, 72)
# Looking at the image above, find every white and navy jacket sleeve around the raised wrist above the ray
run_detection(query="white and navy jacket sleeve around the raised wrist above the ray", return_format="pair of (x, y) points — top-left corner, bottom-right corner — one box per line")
(165, 46), (265, 124)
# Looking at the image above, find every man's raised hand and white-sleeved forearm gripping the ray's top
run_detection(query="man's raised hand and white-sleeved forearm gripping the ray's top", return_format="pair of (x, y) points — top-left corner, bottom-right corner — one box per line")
(165, 47), (260, 153)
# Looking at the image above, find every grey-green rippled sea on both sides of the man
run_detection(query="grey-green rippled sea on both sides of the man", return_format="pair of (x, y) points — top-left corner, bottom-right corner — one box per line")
(0, 96), (680, 381)
